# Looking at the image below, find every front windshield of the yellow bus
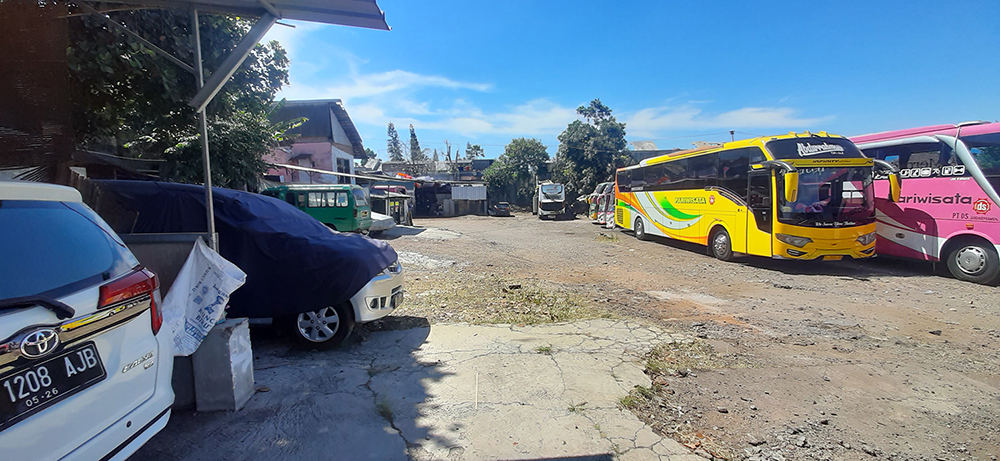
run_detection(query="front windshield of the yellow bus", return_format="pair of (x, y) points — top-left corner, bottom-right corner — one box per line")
(776, 167), (875, 227)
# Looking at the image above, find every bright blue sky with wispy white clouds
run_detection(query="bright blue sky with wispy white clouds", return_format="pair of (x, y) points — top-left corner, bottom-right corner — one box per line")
(267, 0), (1000, 158)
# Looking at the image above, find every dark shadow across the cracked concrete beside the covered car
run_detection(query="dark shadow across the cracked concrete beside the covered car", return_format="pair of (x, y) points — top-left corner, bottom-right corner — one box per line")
(134, 317), (452, 460)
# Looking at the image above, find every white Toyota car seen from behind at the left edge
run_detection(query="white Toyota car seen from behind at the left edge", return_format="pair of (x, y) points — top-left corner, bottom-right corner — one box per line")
(0, 181), (174, 460)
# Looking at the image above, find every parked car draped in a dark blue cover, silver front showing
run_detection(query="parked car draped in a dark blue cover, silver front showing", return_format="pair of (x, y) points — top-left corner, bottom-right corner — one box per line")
(94, 181), (403, 349)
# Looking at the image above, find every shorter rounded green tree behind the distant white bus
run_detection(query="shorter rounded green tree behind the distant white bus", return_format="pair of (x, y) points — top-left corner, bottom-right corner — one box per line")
(483, 138), (549, 206)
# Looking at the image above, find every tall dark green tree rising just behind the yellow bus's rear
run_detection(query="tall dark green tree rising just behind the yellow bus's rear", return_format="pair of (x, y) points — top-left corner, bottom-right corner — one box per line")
(553, 99), (634, 200)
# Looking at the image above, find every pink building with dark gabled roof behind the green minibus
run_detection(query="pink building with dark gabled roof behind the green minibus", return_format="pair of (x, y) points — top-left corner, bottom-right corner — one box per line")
(264, 99), (366, 184)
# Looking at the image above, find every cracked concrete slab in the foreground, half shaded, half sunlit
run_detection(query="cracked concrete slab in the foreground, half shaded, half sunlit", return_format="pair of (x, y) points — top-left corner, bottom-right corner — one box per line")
(135, 320), (703, 461)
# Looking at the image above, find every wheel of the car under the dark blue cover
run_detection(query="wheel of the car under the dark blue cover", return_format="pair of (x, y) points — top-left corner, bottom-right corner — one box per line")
(284, 303), (354, 350)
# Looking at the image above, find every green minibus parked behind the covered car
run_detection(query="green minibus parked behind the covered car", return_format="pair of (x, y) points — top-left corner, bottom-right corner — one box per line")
(261, 184), (372, 234)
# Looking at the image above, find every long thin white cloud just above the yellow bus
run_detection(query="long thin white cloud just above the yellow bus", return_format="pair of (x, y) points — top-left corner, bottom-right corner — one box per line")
(623, 105), (833, 137)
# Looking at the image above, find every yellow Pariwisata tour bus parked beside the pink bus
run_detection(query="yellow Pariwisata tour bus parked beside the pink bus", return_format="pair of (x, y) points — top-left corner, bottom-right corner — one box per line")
(615, 132), (899, 260)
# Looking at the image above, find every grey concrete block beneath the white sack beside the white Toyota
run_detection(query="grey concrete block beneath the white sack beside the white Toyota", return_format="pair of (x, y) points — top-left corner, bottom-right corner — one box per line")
(191, 318), (254, 411)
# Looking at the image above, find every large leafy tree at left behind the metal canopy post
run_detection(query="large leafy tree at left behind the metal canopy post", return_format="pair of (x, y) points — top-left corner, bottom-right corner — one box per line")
(67, 9), (289, 188)
